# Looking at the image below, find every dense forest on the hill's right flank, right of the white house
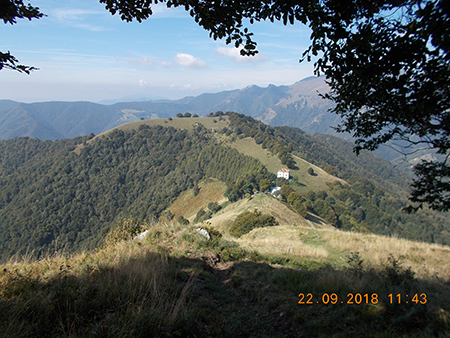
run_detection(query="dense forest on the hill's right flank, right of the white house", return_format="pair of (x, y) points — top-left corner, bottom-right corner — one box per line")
(220, 113), (450, 245)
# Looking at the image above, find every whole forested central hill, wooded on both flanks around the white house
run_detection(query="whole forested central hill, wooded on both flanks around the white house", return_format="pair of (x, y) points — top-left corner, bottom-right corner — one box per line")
(0, 112), (450, 259)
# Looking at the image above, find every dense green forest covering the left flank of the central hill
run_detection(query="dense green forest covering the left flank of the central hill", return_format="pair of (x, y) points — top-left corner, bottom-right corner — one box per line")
(0, 125), (273, 259)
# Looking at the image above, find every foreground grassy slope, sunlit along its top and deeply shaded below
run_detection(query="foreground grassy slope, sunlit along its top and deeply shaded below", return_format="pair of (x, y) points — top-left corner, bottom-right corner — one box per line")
(0, 217), (450, 337)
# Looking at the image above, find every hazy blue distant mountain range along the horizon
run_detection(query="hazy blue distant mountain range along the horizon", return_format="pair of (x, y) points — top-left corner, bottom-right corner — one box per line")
(0, 77), (339, 140)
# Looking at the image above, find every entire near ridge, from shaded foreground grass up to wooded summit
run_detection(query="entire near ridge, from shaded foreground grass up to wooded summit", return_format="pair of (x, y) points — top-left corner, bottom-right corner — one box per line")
(0, 112), (450, 337)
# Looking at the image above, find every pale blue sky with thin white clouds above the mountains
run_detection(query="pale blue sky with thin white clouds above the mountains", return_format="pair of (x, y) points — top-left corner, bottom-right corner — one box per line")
(0, 0), (313, 102)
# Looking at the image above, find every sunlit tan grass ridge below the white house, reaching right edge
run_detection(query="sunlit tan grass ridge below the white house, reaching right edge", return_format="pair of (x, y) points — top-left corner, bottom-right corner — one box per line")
(183, 180), (450, 278)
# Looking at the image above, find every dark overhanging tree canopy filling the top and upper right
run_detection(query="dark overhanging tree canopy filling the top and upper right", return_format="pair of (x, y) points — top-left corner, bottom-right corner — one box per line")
(100, 0), (450, 211)
